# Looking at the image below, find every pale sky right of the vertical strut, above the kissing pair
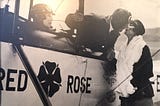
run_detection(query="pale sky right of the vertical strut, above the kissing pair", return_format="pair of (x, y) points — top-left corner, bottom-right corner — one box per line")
(85, 0), (160, 28)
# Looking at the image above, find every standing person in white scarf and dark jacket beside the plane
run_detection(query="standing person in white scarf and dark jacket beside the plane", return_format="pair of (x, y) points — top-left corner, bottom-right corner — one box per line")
(115, 20), (154, 106)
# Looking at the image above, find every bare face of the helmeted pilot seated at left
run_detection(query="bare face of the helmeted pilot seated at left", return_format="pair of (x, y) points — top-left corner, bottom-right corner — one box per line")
(43, 14), (53, 28)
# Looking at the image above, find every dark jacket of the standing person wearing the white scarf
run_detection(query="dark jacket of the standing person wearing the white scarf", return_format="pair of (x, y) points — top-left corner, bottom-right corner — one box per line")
(130, 46), (154, 100)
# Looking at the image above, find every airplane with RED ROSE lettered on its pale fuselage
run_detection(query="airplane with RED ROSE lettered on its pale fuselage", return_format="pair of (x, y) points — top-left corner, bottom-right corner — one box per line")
(0, 0), (160, 106)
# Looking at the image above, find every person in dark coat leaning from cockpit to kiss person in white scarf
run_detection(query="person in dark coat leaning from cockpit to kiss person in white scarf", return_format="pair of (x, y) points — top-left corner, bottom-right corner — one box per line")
(65, 8), (131, 59)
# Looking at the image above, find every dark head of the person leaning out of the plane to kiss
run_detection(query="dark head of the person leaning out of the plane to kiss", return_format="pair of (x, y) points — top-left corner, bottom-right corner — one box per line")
(111, 8), (131, 30)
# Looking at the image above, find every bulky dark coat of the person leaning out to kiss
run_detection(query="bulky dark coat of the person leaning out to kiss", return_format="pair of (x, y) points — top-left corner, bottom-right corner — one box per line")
(65, 14), (119, 53)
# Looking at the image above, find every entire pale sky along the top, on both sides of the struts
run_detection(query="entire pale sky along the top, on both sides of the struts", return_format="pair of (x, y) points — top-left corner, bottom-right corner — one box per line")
(0, 0), (160, 28)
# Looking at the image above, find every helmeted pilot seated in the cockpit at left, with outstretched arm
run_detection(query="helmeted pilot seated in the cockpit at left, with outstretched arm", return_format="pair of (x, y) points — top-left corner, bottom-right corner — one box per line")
(21, 4), (73, 51)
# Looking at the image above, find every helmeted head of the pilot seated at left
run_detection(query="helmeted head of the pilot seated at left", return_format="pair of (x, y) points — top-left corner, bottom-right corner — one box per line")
(29, 4), (55, 32)
